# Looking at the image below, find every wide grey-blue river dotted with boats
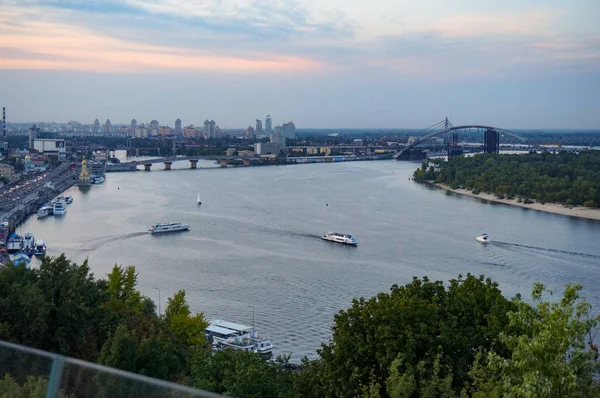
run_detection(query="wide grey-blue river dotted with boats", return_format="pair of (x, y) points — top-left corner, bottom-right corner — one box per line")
(19, 161), (600, 361)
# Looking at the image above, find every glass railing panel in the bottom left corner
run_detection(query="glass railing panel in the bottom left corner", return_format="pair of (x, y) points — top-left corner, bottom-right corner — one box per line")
(0, 341), (222, 398)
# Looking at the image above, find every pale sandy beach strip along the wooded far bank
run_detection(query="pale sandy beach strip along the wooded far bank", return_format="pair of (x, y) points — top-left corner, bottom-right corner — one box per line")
(431, 183), (600, 221)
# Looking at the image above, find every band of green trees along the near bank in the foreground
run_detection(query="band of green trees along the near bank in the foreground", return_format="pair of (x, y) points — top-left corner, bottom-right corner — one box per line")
(0, 256), (600, 398)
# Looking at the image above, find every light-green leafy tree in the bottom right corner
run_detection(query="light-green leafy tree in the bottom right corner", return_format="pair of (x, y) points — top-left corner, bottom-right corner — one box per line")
(471, 283), (600, 398)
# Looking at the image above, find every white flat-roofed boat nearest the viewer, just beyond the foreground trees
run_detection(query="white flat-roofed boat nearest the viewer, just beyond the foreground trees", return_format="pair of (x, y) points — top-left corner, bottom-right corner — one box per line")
(206, 319), (273, 355)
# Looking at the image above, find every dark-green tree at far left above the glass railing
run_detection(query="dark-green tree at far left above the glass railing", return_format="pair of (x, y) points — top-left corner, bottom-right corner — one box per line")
(0, 255), (106, 361)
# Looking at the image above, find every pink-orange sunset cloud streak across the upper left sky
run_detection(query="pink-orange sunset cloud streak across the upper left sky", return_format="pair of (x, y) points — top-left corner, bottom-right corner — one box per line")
(0, 16), (323, 72)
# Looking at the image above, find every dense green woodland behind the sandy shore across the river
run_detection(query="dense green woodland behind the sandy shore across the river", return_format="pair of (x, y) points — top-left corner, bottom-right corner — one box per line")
(414, 151), (600, 207)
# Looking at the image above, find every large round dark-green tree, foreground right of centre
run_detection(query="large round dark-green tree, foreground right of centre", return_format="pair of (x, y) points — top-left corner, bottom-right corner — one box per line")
(320, 275), (515, 396)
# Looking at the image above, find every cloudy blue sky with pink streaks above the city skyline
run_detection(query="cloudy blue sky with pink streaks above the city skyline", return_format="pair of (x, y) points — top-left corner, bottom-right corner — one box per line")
(0, 0), (600, 129)
